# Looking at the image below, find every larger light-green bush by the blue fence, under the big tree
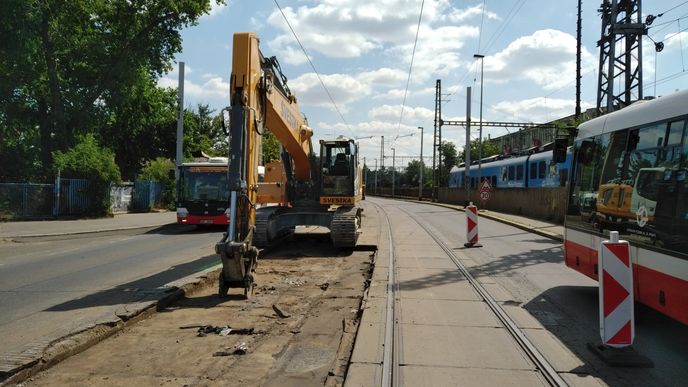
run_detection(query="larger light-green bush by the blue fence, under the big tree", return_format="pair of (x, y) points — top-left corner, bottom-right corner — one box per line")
(53, 134), (122, 215)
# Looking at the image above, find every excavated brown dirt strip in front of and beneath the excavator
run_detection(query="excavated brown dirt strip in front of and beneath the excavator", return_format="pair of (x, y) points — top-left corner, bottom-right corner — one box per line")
(21, 230), (374, 387)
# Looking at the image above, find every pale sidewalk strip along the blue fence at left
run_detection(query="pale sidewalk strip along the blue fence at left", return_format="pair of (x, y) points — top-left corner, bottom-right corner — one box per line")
(0, 211), (177, 239)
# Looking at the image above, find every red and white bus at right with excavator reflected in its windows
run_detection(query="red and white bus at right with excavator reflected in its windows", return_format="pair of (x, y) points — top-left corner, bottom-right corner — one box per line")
(564, 91), (688, 324)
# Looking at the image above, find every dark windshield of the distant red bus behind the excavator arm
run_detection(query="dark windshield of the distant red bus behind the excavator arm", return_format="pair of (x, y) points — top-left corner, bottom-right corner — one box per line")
(179, 167), (229, 202)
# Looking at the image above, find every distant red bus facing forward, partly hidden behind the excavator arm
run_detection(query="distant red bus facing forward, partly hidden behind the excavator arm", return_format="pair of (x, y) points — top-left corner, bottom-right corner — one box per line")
(177, 157), (229, 225)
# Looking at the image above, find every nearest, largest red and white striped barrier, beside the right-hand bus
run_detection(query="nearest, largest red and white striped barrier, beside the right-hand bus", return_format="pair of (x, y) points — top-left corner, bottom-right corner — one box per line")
(599, 231), (635, 348)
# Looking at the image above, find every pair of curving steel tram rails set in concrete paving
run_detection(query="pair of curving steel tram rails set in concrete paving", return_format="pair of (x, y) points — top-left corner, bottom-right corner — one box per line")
(374, 203), (568, 386)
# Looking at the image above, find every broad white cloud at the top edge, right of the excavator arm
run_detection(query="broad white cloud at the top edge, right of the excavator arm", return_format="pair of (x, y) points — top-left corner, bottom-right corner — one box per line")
(267, 0), (478, 68)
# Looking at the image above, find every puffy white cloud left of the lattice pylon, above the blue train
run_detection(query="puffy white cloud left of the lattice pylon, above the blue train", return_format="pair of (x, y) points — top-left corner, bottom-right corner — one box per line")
(483, 29), (596, 90)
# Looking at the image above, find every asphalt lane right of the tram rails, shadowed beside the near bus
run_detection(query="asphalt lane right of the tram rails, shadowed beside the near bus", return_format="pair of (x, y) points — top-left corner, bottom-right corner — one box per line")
(396, 203), (688, 386)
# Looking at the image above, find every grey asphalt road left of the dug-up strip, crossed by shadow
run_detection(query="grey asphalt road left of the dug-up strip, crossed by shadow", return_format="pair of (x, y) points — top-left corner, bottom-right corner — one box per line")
(0, 227), (222, 355)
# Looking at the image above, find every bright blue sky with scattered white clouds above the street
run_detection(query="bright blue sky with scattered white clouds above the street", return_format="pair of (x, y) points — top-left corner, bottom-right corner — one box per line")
(159, 0), (688, 167)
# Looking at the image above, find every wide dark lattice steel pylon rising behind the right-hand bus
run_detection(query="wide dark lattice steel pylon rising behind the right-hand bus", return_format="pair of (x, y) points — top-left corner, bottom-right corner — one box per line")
(597, 0), (647, 113)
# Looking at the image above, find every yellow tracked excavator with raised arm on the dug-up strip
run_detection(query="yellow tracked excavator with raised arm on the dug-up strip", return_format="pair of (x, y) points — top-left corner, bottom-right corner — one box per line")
(215, 32), (363, 298)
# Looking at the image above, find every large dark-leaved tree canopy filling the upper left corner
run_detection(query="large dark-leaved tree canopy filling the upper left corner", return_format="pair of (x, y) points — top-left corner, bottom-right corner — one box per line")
(0, 0), (222, 177)
